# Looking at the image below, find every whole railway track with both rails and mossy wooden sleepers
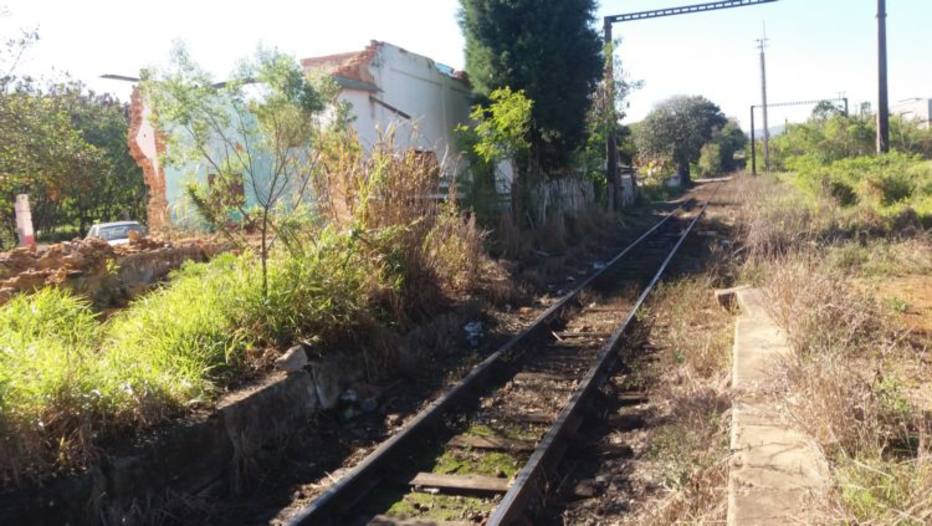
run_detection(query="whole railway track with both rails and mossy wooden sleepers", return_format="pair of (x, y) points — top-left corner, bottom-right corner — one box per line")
(286, 188), (708, 526)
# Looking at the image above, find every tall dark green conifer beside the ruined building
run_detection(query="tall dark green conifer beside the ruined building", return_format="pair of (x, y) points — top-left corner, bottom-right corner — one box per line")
(459, 0), (602, 169)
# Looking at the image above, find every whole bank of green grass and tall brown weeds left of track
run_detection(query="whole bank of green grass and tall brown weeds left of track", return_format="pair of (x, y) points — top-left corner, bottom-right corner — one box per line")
(0, 74), (488, 485)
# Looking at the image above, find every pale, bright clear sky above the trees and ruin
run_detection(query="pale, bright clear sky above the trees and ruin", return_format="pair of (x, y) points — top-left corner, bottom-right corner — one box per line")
(0, 0), (932, 131)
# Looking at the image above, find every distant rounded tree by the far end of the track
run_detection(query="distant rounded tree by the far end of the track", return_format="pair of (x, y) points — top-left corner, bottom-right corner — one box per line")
(635, 95), (728, 183)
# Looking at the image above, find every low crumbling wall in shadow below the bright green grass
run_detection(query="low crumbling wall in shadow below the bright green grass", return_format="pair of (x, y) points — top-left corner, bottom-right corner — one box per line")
(0, 369), (321, 526)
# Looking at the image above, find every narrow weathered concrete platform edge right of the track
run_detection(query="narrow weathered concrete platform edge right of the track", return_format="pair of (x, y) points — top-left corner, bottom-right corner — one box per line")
(728, 288), (829, 526)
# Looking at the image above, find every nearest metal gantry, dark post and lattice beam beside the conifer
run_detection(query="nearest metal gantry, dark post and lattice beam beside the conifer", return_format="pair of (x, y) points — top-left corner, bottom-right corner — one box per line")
(604, 0), (778, 203)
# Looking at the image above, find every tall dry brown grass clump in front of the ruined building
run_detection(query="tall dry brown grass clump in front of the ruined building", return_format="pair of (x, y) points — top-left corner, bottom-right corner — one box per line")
(313, 131), (492, 320)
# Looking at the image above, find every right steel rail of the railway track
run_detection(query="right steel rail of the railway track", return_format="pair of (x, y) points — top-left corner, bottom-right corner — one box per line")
(485, 189), (718, 526)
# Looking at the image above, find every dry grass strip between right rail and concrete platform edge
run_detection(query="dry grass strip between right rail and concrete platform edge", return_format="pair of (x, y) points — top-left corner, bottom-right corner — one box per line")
(627, 267), (733, 526)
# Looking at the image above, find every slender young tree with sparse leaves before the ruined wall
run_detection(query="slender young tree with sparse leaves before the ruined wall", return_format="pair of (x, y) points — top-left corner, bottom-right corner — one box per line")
(143, 46), (335, 300)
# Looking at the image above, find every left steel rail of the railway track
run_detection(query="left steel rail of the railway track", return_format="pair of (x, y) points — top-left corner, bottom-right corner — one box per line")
(286, 200), (691, 526)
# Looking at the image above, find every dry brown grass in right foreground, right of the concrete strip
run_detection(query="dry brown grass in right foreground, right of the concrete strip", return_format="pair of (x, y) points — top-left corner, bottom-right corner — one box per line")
(768, 256), (932, 524)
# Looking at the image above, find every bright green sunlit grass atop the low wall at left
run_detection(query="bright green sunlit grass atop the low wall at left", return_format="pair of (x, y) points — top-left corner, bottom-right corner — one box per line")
(0, 241), (377, 483)
